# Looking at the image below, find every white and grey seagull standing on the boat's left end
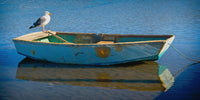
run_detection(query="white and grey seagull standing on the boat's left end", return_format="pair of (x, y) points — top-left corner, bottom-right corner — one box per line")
(29, 11), (51, 32)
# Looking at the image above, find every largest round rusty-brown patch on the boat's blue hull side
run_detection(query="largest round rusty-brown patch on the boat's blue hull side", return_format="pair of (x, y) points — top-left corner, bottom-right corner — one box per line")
(95, 47), (111, 58)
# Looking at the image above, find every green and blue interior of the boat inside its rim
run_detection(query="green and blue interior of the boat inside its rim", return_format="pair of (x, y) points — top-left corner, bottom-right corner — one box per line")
(34, 32), (173, 44)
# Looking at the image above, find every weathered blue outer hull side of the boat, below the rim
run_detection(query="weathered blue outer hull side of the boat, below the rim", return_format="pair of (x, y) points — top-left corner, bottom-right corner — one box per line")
(14, 31), (173, 65)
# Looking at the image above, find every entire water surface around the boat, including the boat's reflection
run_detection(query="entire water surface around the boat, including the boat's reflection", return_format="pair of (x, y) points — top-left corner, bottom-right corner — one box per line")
(0, 0), (200, 100)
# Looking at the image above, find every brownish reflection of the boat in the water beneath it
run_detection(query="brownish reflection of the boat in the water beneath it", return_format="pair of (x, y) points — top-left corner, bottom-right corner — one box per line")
(16, 58), (174, 91)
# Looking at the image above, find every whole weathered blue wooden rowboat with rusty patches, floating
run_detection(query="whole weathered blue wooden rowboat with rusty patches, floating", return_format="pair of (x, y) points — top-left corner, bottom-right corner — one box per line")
(13, 32), (175, 65)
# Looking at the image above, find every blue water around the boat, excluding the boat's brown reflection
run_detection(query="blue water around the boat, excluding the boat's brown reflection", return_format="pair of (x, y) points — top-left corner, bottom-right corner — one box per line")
(0, 0), (200, 100)
